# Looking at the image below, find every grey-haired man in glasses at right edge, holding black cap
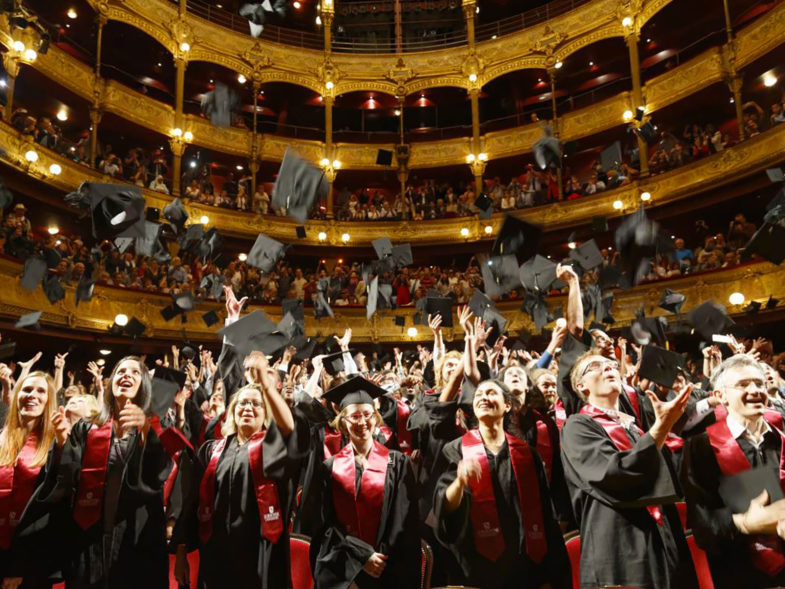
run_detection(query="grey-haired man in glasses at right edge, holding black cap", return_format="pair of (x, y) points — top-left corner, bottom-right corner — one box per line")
(683, 354), (785, 589)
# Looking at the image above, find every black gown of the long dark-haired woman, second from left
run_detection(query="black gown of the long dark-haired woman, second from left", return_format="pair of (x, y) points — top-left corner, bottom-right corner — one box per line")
(42, 420), (172, 589)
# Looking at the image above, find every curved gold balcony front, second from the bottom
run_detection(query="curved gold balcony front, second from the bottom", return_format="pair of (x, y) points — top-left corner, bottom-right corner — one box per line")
(0, 123), (785, 247)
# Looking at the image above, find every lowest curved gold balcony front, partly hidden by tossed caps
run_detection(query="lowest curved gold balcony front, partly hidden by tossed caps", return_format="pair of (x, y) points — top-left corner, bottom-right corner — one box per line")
(0, 258), (785, 346)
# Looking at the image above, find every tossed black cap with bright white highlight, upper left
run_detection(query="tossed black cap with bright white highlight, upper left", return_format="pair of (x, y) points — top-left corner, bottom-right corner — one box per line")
(89, 183), (145, 240)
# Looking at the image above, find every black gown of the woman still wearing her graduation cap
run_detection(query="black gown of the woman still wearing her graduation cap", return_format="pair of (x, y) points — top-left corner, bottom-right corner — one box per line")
(311, 442), (421, 589)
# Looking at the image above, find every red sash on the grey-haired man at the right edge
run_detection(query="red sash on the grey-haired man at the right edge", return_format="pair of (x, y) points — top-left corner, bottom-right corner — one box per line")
(706, 416), (785, 577)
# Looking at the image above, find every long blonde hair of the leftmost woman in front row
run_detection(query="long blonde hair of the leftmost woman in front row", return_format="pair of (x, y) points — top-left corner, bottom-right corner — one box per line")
(0, 370), (57, 466)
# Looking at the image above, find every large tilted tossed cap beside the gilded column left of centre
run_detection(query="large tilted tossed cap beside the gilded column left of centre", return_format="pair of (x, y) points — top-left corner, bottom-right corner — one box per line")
(272, 149), (329, 225)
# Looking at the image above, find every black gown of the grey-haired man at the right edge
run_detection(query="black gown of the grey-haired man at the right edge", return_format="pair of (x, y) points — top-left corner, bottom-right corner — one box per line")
(682, 424), (785, 589)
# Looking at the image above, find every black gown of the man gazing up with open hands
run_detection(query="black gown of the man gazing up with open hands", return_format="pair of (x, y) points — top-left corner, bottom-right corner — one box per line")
(562, 414), (697, 589)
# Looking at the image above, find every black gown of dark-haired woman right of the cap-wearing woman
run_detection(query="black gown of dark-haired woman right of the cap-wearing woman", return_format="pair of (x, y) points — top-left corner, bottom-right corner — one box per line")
(433, 439), (571, 589)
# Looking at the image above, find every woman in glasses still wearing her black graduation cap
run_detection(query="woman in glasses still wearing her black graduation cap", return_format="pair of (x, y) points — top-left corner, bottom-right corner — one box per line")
(309, 376), (421, 589)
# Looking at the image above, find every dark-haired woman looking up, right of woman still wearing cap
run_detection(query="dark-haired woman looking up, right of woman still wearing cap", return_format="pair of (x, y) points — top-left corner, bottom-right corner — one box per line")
(434, 380), (571, 589)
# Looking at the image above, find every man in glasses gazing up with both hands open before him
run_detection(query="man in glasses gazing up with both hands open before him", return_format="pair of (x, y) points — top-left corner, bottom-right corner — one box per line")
(562, 351), (696, 589)
